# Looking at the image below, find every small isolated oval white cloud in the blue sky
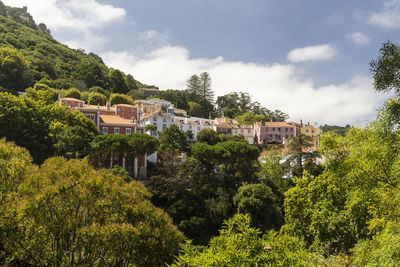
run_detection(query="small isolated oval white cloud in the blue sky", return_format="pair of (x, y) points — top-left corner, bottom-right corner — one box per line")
(287, 44), (337, 62)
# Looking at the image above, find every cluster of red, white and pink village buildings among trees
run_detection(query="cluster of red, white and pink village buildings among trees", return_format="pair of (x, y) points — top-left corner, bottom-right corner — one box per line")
(57, 96), (322, 177)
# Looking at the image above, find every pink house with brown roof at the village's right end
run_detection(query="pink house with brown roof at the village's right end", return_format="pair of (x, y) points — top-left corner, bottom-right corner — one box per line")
(254, 120), (301, 144)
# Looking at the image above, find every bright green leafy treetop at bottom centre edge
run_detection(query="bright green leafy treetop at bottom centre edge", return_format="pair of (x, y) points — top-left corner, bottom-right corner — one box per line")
(172, 214), (307, 266)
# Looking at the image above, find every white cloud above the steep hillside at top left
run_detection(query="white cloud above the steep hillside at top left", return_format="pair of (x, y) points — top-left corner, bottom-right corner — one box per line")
(3, 0), (126, 50)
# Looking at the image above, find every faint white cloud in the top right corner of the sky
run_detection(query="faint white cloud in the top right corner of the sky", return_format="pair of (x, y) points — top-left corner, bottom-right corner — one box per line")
(369, 0), (400, 29)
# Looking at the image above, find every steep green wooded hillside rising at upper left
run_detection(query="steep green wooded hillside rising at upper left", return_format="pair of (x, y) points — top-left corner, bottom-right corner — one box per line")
(0, 1), (155, 93)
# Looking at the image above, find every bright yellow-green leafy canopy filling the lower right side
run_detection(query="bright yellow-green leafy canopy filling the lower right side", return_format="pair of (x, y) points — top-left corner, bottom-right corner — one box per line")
(285, 102), (400, 253)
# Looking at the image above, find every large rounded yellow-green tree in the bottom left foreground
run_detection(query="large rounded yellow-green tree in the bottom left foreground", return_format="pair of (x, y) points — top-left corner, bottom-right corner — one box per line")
(2, 158), (184, 266)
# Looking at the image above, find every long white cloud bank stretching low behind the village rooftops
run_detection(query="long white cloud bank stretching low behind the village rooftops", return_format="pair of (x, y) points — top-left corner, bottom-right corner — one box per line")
(101, 46), (385, 124)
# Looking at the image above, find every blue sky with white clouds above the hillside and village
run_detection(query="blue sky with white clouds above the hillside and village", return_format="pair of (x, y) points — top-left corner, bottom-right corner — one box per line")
(3, 0), (400, 125)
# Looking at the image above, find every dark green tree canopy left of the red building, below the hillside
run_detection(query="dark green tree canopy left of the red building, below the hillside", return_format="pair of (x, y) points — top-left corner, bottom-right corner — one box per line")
(0, 89), (98, 163)
